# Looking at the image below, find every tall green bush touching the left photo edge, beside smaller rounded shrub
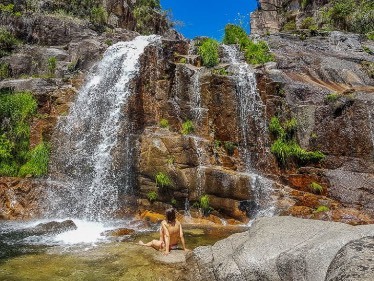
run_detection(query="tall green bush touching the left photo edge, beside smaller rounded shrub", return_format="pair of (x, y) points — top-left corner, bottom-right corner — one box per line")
(0, 91), (37, 176)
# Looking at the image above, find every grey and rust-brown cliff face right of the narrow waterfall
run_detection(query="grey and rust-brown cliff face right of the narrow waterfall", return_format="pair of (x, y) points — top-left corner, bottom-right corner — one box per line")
(259, 32), (374, 220)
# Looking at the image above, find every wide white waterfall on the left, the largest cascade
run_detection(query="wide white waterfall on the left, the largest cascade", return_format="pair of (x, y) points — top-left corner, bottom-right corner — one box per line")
(47, 36), (158, 220)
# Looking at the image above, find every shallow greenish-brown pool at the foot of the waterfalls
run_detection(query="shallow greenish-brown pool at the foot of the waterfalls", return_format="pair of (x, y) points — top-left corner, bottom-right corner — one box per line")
(0, 220), (246, 281)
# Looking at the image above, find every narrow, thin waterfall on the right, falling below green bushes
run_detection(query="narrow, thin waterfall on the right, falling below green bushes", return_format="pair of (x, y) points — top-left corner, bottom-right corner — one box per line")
(223, 45), (274, 217)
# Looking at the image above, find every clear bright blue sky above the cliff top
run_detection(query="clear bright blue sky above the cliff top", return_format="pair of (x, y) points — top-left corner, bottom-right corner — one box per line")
(160, 0), (257, 40)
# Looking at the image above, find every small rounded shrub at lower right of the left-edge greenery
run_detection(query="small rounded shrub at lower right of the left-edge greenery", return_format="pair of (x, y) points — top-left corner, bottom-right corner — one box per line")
(18, 142), (49, 177)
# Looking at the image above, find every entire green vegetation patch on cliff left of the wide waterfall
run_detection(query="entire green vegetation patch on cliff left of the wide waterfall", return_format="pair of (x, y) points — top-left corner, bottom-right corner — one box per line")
(0, 91), (49, 176)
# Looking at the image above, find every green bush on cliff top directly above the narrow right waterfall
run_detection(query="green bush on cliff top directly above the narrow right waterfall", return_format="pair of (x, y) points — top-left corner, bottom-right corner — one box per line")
(223, 24), (274, 64)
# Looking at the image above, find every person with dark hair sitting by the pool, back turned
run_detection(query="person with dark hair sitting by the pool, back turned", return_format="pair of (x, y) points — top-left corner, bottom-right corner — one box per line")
(139, 208), (188, 255)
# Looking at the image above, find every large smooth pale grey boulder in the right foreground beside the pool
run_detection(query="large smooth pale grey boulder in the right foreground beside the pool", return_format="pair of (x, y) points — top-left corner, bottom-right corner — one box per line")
(187, 217), (374, 281)
